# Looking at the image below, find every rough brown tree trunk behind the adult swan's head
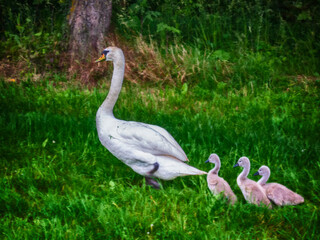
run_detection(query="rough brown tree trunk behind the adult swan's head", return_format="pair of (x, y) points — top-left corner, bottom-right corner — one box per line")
(69, 0), (112, 64)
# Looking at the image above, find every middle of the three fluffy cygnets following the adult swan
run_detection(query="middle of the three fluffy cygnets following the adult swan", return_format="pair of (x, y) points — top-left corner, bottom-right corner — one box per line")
(233, 157), (272, 208)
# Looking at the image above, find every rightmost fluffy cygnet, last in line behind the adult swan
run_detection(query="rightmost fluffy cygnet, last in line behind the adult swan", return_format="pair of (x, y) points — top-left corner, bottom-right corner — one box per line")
(254, 166), (304, 206)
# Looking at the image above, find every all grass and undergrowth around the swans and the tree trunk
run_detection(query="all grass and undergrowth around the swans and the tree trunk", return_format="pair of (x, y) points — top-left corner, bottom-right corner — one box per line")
(0, 1), (320, 239)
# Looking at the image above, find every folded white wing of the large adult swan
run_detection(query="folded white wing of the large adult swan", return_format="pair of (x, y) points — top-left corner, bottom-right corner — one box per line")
(117, 121), (187, 161)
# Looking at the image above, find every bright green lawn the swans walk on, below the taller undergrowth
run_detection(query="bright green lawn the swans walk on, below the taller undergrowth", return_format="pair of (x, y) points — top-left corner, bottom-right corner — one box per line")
(0, 72), (320, 239)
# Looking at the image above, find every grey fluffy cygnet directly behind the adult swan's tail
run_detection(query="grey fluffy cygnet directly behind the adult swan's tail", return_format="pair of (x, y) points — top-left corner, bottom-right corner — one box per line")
(206, 153), (237, 204)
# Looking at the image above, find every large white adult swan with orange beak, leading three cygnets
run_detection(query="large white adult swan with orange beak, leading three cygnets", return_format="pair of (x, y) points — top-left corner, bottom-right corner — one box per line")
(96, 47), (207, 189)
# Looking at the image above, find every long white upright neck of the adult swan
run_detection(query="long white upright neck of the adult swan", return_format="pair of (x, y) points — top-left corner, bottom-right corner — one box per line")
(100, 54), (125, 116)
